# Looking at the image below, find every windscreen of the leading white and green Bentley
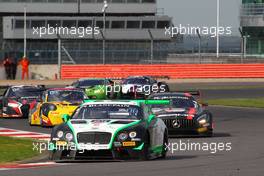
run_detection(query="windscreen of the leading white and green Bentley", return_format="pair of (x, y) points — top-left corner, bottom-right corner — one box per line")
(72, 104), (143, 120)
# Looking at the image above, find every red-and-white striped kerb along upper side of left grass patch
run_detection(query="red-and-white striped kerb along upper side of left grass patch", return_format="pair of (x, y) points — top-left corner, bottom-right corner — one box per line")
(0, 128), (50, 141)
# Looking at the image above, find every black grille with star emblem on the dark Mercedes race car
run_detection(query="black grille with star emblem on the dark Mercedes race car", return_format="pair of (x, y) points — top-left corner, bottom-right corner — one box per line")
(163, 119), (196, 129)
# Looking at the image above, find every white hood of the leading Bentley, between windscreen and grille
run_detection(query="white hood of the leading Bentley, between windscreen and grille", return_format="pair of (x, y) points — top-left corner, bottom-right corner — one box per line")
(70, 119), (140, 134)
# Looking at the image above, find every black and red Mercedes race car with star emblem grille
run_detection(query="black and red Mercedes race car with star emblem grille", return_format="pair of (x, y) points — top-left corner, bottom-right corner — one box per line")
(149, 92), (213, 137)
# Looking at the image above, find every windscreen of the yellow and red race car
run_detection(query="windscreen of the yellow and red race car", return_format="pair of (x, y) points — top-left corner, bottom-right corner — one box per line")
(48, 90), (86, 103)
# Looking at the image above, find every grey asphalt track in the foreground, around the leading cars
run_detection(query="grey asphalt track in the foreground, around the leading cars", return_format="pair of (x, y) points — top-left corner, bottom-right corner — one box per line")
(0, 86), (264, 176)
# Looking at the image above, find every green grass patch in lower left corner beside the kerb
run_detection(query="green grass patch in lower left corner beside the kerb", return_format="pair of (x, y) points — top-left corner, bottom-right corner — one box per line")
(0, 136), (39, 163)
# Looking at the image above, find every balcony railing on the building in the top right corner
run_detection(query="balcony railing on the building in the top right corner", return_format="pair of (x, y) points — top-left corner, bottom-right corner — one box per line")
(240, 3), (264, 16)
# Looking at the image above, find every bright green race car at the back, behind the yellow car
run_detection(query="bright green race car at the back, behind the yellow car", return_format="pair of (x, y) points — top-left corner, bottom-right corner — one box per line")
(70, 78), (120, 100)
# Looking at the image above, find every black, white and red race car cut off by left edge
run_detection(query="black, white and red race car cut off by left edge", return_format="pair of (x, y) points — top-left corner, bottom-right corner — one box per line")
(0, 85), (45, 118)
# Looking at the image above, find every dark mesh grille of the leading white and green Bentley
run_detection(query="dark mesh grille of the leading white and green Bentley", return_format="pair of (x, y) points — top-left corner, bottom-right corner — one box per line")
(77, 132), (112, 144)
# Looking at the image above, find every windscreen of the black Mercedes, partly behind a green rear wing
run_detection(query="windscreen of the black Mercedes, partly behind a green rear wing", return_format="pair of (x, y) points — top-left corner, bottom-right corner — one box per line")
(151, 96), (198, 108)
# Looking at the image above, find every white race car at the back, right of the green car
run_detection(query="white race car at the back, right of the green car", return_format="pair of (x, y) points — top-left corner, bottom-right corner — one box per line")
(121, 76), (169, 99)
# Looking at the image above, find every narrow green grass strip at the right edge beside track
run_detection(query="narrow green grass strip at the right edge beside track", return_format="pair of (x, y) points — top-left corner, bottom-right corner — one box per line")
(207, 98), (264, 108)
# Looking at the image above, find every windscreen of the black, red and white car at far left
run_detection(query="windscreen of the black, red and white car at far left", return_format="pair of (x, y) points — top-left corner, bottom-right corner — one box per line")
(8, 87), (43, 98)
